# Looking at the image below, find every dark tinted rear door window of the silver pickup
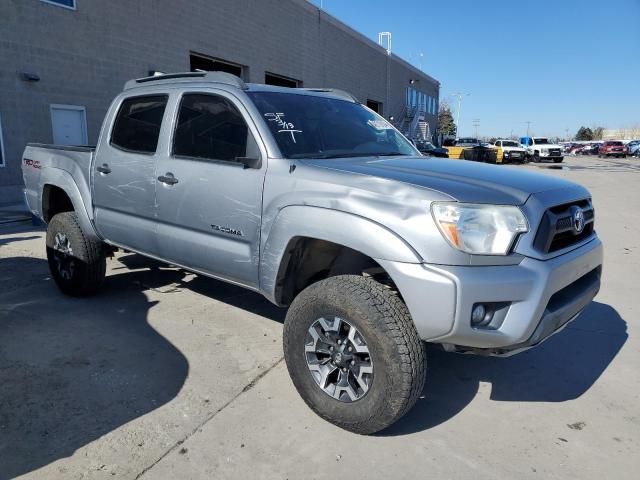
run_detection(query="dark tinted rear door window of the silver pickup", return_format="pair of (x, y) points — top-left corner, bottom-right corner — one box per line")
(111, 95), (168, 153)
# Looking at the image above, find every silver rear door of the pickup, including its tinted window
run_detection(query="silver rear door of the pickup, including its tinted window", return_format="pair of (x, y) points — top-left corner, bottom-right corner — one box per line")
(92, 93), (169, 255)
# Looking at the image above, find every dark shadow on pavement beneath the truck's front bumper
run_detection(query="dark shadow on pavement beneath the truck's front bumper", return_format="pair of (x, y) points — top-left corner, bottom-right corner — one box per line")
(381, 302), (628, 436)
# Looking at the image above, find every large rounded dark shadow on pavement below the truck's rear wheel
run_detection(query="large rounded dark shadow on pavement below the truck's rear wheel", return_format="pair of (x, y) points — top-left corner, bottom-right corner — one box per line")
(0, 257), (189, 480)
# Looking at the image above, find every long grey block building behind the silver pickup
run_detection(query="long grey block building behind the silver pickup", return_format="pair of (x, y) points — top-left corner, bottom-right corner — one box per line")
(0, 0), (440, 204)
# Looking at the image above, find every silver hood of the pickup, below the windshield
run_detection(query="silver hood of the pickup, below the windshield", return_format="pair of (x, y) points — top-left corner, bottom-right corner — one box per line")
(303, 156), (589, 205)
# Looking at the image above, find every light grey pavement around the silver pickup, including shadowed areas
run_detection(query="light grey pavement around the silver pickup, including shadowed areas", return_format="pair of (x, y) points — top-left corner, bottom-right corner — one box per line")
(0, 157), (640, 480)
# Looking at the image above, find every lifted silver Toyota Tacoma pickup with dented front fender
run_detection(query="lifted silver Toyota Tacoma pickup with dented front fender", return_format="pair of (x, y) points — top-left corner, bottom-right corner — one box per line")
(23, 72), (602, 433)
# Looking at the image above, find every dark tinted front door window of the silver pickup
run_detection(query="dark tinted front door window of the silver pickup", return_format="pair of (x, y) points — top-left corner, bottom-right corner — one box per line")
(173, 93), (257, 162)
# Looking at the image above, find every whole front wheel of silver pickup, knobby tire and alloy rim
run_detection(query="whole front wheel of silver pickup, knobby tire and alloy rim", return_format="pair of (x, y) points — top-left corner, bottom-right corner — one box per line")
(284, 275), (426, 434)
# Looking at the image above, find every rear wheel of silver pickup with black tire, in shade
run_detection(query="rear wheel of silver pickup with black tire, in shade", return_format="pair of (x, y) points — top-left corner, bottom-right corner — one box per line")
(47, 212), (107, 297)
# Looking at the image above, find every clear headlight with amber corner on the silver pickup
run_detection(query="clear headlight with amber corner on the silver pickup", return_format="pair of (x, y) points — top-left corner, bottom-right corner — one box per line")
(431, 202), (529, 255)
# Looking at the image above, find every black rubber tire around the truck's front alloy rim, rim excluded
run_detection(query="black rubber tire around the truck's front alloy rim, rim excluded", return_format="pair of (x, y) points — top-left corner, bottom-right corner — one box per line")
(284, 275), (426, 434)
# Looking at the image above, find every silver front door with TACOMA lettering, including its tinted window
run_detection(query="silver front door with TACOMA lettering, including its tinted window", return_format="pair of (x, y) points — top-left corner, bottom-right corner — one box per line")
(156, 89), (266, 286)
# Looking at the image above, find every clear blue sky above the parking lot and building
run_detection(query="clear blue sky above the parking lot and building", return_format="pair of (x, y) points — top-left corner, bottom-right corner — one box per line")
(313, 0), (640, 136)
